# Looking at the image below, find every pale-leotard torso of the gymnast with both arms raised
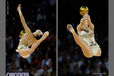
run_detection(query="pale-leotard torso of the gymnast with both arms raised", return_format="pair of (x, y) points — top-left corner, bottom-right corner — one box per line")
(78, 26), (99, 55)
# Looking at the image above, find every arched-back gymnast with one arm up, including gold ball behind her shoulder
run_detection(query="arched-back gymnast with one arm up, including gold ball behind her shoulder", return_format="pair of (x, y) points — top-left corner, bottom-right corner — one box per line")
(16, 4), (49, 58)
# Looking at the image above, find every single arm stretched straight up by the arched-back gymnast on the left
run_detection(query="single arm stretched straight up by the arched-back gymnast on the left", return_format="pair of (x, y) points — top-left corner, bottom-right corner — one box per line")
(17, 4), (31, 32)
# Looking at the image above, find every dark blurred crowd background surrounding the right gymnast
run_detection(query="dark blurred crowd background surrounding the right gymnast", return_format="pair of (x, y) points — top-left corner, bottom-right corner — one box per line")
(58, 0), (108, 76)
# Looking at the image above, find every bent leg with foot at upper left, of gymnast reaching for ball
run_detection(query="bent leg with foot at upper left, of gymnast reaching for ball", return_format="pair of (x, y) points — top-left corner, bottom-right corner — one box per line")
(67, 24), (93, 58)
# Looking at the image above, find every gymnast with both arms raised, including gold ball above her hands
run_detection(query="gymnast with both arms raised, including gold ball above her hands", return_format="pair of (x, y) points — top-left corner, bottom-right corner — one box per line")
(67, 6), (101, 58)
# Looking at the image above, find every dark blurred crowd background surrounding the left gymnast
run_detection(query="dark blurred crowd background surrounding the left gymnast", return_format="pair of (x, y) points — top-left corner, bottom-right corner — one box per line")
(6, 0), (56, 76)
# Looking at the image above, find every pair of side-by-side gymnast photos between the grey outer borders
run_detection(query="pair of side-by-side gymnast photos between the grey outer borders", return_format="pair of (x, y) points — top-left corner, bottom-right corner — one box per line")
(6, 0), (108, 76)
